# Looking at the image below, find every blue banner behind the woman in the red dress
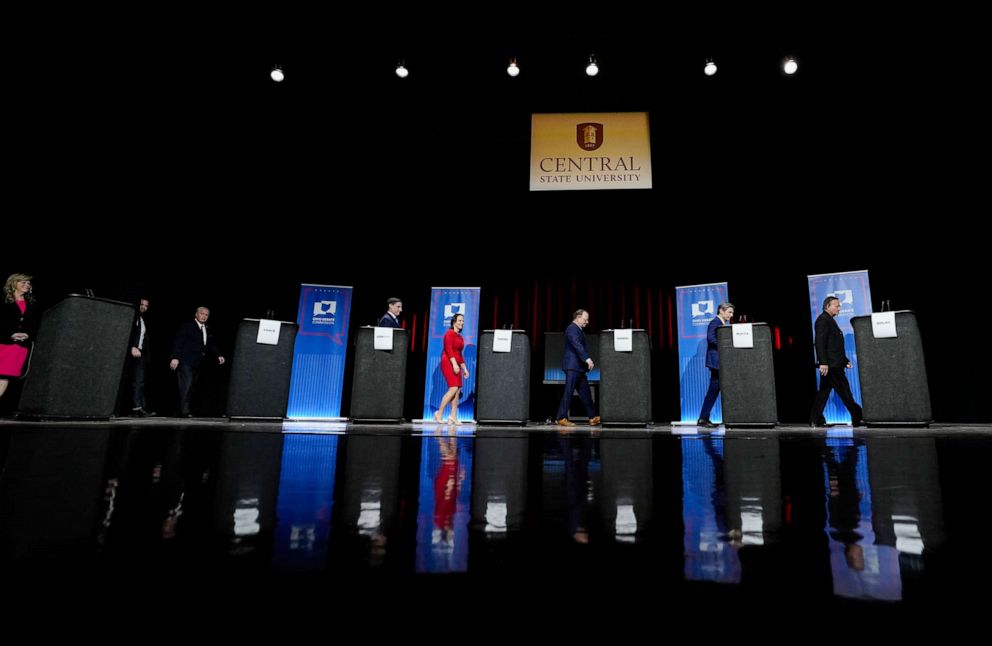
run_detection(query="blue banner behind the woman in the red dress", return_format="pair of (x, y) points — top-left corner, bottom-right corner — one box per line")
(423, 287), (481, 421)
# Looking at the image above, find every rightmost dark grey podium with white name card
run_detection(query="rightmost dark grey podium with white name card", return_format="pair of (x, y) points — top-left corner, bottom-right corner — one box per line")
(851, 310), (933, 426)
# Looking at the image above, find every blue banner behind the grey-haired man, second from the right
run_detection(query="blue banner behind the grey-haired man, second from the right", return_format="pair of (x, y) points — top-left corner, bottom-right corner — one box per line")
(675, 283), (727, 424)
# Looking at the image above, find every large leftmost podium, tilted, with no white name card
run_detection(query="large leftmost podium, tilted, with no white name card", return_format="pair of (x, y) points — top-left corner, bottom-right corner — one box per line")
(18, 294), (135, 419)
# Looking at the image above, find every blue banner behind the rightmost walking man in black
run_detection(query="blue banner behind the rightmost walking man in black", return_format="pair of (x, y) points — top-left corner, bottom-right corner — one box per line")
(807, 270), (871, 424)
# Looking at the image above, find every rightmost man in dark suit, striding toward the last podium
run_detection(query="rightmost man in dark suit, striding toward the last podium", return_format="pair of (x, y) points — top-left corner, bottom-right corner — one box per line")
(809, 296), (864, 426)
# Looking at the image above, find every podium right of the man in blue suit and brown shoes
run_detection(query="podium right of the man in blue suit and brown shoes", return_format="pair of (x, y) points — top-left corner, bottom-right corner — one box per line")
(599, 330), (651, 425)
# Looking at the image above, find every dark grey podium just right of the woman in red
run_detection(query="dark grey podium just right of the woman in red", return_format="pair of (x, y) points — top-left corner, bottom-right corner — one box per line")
(475, 330), (530, 424)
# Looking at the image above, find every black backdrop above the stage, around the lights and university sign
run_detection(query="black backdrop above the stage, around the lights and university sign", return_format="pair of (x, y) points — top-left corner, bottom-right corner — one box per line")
(0, 24), (992, 422)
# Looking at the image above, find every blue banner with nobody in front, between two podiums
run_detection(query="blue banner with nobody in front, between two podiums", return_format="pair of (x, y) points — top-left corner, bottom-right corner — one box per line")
(286, 284), (351, 419)
